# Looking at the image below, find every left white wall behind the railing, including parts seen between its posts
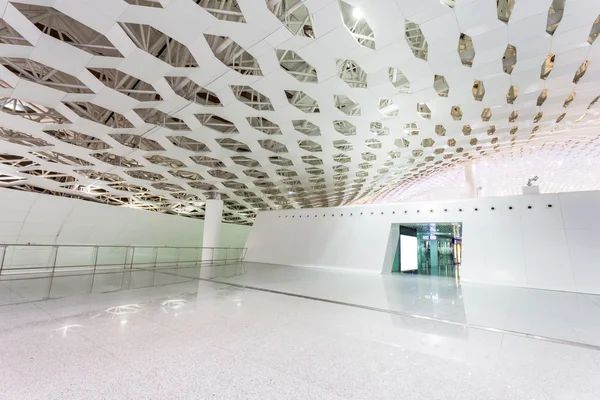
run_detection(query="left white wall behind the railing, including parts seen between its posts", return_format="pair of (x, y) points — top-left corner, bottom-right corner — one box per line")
(0, 189), (250, 272)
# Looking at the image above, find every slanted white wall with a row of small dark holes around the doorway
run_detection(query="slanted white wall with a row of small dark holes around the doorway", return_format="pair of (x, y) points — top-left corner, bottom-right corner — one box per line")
(246, 191), (600, 293)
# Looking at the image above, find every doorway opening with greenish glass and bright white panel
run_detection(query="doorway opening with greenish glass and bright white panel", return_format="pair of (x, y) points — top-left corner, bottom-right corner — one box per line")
(392, 222), (463, 279)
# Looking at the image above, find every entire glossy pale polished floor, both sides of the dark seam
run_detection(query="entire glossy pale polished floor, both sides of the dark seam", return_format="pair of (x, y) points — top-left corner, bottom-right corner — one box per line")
(0, 264), (600, 400)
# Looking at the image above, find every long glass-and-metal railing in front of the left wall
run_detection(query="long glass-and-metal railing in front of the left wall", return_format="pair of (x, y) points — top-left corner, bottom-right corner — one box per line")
(0, 244), (246, 300)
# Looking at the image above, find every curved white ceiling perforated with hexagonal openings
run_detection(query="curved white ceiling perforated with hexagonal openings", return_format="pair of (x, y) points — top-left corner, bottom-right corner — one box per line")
(0, 0), (600, 223)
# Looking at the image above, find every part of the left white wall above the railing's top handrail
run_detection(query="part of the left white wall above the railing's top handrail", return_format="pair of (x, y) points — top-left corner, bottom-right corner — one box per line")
(0, 189), (250, 247)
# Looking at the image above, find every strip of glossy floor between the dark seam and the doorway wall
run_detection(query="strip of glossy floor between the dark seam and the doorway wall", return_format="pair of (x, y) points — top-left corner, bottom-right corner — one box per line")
(210, 264), (600, 346)
